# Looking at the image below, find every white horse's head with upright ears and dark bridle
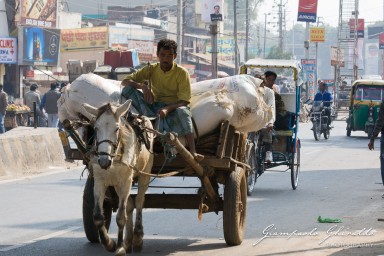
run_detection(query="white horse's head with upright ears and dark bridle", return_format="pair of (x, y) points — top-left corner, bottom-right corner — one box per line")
(82, 100), (132, 170)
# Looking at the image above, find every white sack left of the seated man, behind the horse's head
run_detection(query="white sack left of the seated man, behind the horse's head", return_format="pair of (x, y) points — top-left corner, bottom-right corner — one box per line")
(57, 73), (125, 122)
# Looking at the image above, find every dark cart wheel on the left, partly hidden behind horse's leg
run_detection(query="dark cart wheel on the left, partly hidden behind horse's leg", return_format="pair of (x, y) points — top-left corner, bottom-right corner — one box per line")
(83, 176), (112, 243)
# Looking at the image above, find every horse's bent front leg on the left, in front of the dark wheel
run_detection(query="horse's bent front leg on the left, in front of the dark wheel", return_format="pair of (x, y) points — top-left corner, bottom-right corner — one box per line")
(93, 178), (116, 252)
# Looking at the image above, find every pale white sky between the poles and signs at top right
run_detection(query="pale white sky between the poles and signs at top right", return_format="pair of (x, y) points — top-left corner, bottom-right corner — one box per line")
(259, 0), (384, 29)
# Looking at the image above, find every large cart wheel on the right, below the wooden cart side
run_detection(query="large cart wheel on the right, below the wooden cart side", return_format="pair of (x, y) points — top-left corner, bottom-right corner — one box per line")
(223, 167), (247, 246)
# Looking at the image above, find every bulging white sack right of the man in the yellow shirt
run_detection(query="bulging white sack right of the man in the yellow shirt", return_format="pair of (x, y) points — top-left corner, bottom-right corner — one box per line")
(191, 75), (272, 136)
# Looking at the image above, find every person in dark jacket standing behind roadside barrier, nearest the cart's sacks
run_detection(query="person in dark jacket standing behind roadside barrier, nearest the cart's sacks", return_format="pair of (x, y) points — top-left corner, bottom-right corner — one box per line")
(40, 83), (61, 127)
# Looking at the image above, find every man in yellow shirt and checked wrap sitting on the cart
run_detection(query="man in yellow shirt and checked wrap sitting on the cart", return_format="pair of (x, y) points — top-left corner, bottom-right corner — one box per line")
(121, 39), (203, 161)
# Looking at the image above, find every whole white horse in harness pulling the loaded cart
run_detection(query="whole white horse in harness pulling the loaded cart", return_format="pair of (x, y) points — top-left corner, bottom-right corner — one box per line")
(82, 100), (154, 255)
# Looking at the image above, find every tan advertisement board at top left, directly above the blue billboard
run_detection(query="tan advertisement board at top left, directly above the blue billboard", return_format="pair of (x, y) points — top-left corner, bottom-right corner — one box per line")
(20, 0), (58, 28)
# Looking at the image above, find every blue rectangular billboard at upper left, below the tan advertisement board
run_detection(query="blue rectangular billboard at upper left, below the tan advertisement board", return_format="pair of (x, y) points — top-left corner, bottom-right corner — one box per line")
(18, 27), (60, 66)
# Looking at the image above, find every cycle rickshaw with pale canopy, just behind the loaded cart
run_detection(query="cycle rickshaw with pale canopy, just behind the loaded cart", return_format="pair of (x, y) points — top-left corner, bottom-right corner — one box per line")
(240, 59), (302, 195)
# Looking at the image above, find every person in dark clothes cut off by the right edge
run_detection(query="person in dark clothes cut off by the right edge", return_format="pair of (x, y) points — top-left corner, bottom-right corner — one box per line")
(368, 101), (384, 198)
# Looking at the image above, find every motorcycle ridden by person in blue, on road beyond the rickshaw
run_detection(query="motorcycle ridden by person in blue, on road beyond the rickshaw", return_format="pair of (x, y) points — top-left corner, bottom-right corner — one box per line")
(311, 101), (332, 140)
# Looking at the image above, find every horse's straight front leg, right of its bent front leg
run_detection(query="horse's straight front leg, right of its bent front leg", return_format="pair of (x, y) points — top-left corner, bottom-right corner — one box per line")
(115, 177), (132, 255)
